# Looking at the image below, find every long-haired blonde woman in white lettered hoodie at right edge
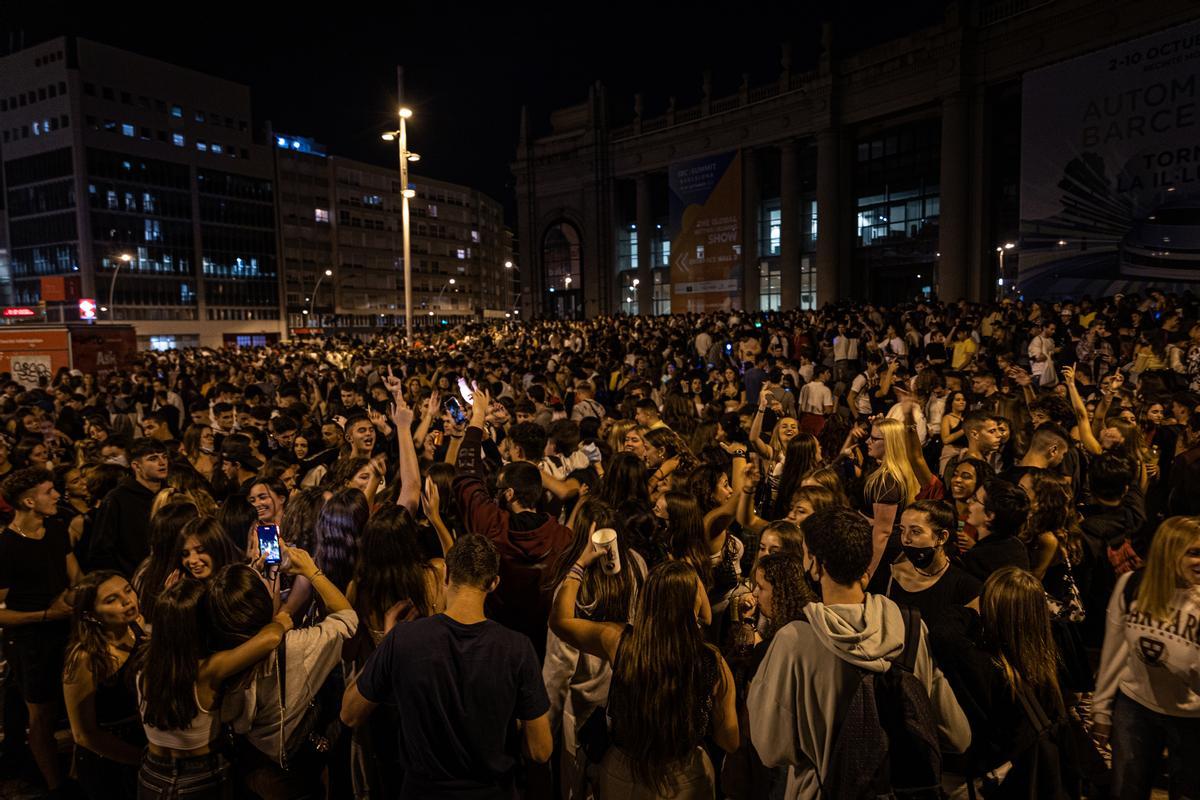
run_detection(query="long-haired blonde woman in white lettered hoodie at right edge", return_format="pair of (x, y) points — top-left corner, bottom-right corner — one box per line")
(1092, 517), (1200, 799)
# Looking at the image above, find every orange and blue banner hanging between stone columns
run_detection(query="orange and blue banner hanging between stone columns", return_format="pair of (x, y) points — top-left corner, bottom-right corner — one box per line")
(668, 152), (742, 313)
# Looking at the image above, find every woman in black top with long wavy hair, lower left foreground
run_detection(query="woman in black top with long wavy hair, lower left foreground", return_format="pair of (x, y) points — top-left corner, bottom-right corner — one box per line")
(62, 570), (145, 800)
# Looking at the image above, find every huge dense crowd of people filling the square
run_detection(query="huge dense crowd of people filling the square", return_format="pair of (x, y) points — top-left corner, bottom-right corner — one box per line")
(0, 291), (1200, 800)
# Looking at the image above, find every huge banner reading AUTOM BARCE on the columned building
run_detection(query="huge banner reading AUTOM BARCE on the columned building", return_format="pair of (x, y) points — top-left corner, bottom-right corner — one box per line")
(1018, 23), (1200, 297)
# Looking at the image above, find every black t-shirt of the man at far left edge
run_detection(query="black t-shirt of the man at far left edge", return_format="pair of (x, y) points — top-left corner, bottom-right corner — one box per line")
(0, 518), (71, 639)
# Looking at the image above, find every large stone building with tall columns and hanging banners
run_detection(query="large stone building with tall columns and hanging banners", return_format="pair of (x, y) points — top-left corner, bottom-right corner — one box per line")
(512, 0), (1200, 318)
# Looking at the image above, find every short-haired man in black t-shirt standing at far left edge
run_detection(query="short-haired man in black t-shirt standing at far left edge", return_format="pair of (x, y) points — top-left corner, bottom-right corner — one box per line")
(0, 467), (80, 792)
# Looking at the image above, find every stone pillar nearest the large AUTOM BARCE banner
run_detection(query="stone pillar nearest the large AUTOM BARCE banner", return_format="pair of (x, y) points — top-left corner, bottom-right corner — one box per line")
(937, 92), (970, 302)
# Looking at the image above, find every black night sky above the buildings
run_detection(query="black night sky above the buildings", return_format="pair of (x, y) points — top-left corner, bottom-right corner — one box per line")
(0, 0), (944, 224)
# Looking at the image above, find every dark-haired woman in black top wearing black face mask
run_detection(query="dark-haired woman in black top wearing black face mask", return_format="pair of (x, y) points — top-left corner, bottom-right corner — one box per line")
(888, 500), (980, 630)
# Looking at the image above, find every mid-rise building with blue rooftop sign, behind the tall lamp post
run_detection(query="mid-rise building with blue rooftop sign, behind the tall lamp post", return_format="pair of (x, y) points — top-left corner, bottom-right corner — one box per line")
(270, 132), (512, 336)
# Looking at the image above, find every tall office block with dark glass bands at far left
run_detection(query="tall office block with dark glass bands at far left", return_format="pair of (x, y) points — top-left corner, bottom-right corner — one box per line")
(0, 37), (282, 348)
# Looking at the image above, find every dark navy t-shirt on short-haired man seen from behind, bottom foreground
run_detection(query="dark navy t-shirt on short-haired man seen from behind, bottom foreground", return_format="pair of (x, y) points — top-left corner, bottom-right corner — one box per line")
(358, 614), (550, 798)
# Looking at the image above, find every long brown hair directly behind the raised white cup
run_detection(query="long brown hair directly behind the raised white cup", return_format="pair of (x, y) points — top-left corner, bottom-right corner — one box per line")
(552, 498), (644, 622)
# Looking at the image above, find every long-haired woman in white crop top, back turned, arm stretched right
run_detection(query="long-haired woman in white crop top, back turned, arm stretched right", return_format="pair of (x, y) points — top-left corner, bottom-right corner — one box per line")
(136, 581), (292, 800)
